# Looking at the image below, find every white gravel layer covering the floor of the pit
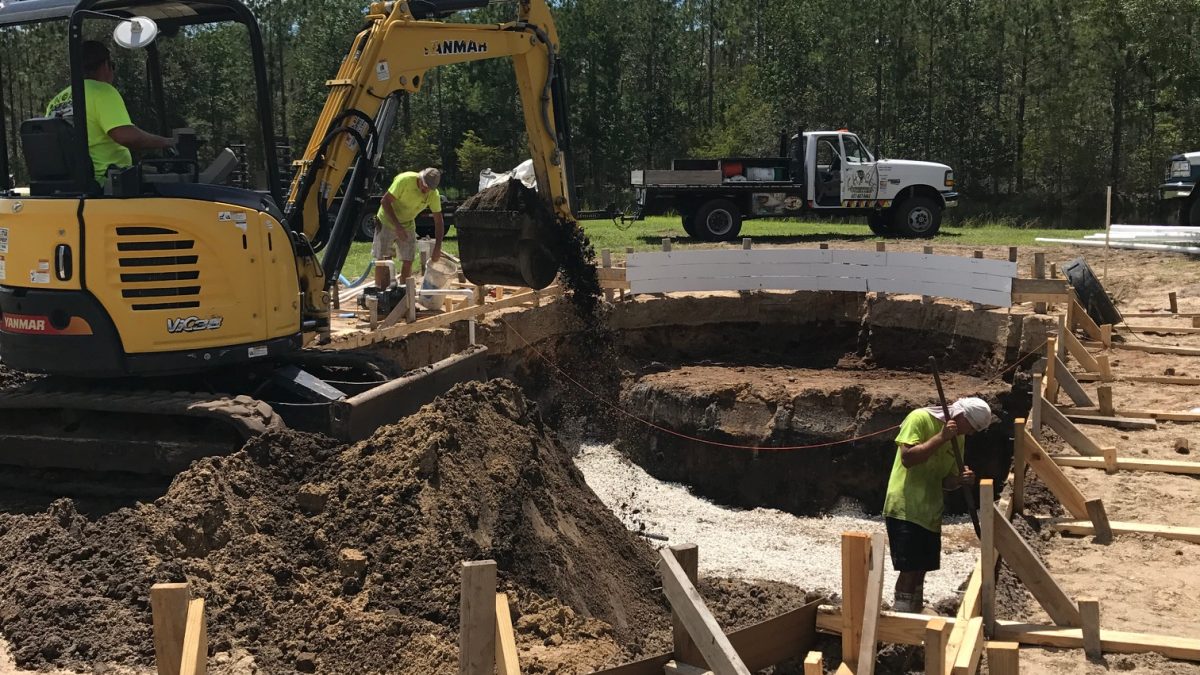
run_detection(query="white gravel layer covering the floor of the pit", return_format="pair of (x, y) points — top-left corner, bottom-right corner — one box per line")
(575, 446), (978, 605)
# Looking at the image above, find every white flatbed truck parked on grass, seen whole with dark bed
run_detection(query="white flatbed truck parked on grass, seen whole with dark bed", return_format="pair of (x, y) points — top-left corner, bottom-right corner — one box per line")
(630, 130), (959, 241)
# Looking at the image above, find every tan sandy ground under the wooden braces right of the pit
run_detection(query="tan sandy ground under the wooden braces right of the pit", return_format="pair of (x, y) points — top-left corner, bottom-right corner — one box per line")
(1021, 243), (1200, 674)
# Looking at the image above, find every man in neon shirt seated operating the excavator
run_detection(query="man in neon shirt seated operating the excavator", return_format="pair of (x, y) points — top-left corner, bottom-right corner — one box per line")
(46, 40), (175, 185)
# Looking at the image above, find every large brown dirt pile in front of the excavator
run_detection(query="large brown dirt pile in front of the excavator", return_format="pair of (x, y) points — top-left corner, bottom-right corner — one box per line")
(0, 381), (668, 673)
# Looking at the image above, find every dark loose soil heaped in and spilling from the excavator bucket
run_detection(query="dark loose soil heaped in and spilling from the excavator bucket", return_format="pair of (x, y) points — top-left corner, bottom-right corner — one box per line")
(458, 179), (600, 319)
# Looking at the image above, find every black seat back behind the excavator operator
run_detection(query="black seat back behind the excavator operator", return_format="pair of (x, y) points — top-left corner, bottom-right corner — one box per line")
(20, 118), (95, 197)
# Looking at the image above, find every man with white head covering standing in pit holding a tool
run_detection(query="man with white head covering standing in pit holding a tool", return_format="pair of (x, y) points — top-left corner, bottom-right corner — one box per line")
(883, 398), (996, 613)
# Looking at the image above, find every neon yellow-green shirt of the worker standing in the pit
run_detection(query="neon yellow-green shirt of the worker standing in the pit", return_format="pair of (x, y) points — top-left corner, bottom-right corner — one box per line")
(883, 408), (958, 533)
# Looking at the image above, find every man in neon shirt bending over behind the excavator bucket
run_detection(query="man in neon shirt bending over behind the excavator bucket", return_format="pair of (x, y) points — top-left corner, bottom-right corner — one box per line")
(371, 168), (445, 291)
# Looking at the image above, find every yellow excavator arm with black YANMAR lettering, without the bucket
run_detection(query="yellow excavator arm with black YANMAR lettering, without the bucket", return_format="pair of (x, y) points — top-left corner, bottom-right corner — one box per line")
(286, 0), (574, 325)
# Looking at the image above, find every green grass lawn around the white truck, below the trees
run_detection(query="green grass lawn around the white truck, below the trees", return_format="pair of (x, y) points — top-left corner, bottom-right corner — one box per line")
(333, 216), (1098, 280)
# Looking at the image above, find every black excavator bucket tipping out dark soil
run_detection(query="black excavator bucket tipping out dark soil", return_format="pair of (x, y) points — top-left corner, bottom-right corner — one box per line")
(455, 180), (563, 289)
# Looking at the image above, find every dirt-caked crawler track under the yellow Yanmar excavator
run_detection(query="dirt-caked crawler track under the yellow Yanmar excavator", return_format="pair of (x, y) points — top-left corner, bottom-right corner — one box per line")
(0, 378), (284, 477)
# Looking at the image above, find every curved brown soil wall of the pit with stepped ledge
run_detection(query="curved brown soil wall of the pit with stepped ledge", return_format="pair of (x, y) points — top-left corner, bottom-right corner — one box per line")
(360, 293), (1054, 514)
